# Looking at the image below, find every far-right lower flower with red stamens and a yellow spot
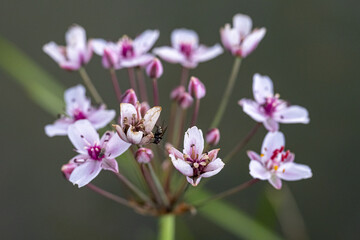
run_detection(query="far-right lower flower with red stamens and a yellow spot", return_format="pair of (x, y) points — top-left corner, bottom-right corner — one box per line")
(248, 132), (312, 189)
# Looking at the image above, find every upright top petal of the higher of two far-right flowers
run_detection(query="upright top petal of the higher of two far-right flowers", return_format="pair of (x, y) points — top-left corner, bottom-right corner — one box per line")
(252, 73), (274, 104)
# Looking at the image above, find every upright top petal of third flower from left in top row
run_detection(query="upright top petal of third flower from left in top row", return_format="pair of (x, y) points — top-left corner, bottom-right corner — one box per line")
(171, 28), (199, 49)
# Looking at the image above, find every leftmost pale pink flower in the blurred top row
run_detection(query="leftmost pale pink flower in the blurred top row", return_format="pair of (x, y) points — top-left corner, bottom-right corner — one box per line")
(43, 25), (92, 71)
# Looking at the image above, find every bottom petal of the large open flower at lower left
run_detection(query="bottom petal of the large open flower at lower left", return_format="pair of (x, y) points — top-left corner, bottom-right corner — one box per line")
(69, 160), (102, 188)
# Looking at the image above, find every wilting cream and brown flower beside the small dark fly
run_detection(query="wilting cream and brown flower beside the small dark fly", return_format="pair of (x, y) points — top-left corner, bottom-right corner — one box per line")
(113, 102), (161, 145)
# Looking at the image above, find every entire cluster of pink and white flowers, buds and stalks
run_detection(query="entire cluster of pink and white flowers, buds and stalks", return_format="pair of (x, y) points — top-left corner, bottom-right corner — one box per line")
(43, 14), (312, 218)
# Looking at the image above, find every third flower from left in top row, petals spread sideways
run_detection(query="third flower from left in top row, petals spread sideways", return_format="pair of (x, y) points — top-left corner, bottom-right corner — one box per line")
(153, 29), (223, 68)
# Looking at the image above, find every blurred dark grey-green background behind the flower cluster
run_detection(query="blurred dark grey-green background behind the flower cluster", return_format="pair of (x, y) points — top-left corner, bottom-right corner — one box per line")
(0, 0), (360, 239)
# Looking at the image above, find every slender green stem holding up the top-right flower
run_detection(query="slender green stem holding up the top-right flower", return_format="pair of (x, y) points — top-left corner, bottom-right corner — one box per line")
(211, 57), (242, 128)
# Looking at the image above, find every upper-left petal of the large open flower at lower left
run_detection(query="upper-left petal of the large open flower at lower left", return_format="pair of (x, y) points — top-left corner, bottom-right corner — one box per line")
(68, 120), (99, 154)
